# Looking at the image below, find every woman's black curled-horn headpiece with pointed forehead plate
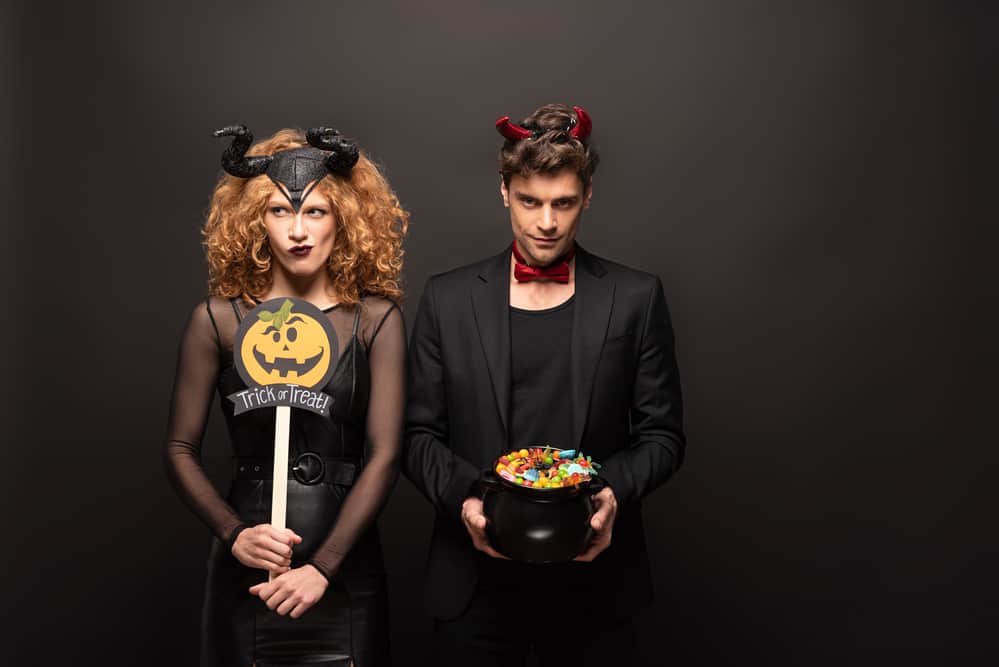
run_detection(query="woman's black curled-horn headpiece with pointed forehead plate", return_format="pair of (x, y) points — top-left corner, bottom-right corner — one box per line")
(215, 125), (360, 212)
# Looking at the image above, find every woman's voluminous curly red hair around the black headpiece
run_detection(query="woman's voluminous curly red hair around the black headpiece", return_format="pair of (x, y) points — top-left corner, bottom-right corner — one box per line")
(202, 129), (409, 305)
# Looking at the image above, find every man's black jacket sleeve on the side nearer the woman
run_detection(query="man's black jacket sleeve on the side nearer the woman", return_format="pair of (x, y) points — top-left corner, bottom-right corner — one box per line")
(403, 279), (479, 521)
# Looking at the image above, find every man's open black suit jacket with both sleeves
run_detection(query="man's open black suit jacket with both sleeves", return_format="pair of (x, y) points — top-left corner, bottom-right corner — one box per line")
(403, 248), (685, 619)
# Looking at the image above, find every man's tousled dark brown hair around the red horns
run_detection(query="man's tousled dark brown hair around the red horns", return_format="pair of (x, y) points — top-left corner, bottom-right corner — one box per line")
(499, 104), (600, 188)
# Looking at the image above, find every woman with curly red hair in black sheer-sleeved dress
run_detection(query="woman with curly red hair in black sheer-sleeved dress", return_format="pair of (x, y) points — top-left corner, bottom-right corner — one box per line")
(165, 126), (408, 667)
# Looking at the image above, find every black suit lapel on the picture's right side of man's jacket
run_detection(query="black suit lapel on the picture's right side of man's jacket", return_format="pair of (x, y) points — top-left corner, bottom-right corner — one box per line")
(570, 248), (614, 449)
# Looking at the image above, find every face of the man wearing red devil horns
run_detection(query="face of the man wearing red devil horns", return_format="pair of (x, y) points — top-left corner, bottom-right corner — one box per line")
(500, 169), (593, 266)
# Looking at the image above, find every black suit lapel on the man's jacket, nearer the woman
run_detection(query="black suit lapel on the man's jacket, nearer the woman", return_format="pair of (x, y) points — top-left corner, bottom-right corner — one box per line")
(472, 249), (511, 442)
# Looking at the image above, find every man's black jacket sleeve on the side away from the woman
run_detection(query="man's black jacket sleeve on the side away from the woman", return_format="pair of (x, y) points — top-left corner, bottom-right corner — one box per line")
(600, 278), (686, 508)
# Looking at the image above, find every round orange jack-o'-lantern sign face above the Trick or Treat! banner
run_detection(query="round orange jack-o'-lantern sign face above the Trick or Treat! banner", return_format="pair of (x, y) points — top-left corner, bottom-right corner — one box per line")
(233, 299), (337, 389)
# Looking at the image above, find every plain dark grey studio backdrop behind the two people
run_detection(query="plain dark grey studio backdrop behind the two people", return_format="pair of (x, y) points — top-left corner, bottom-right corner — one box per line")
(0, 0), (999, 665)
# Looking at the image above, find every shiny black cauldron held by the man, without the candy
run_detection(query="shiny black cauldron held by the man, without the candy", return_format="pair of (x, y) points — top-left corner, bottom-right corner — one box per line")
(479, 460), (604, 563)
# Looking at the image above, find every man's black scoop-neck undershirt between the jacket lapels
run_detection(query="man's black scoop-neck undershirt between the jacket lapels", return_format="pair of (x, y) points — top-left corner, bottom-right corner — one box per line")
(510, 296), (576, 449)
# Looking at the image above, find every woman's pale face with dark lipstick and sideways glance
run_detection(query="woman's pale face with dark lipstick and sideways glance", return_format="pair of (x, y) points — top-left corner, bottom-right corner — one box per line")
(264, 187), (336, 279)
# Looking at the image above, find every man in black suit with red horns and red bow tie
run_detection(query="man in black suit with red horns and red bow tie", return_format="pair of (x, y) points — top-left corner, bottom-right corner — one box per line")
(403, 105), (685, 665)
